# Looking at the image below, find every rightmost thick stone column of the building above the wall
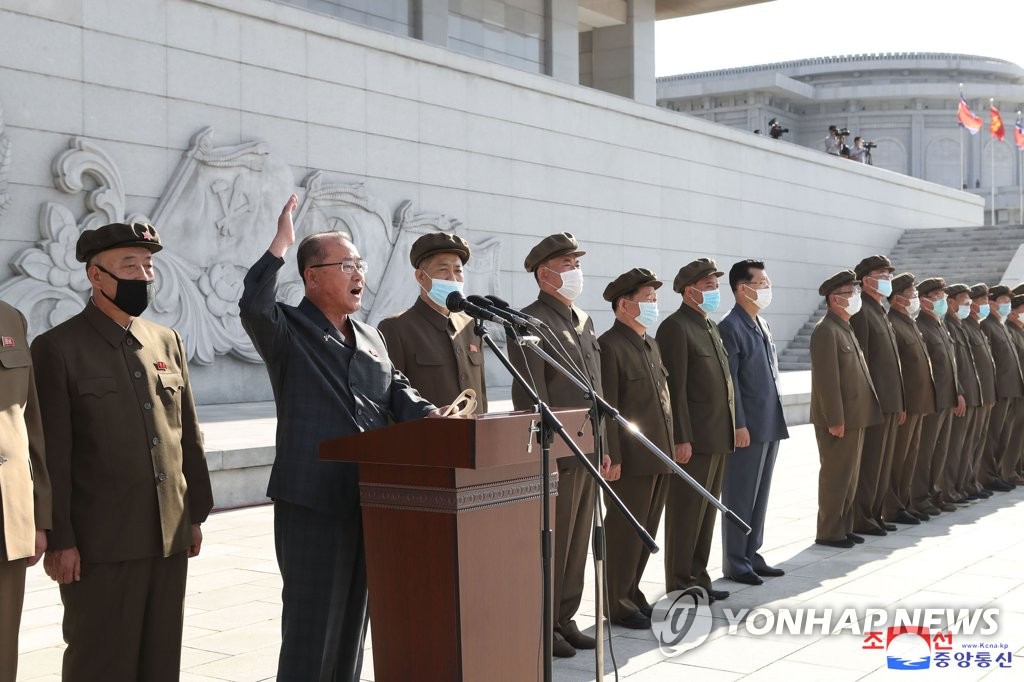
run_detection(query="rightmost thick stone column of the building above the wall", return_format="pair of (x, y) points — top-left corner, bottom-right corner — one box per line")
(593, 0), (657, 104)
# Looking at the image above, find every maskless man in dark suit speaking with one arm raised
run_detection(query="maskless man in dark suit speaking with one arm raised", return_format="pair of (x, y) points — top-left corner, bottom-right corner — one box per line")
(239, 195), (438, 682)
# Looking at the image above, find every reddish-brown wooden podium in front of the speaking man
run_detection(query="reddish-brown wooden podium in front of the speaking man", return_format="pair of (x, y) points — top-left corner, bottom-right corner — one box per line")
(319, 410), (594, 682)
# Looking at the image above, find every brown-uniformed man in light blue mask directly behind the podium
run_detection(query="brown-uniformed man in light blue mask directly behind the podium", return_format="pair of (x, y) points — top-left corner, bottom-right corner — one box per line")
(377, 232), (487, 413)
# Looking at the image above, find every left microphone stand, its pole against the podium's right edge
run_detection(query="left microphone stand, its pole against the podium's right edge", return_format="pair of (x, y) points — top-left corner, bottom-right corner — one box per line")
(470, 312), (658, 682)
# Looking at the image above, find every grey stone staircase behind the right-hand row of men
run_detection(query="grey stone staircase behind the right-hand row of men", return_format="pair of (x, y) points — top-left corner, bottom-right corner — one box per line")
(778, 225), (1024, 371)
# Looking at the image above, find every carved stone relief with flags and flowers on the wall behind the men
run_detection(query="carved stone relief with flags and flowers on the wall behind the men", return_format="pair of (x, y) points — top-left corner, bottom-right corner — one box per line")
(0, 127), (501, 365)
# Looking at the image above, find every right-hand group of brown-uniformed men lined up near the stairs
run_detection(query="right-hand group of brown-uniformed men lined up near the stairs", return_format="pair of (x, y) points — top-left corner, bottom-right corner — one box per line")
(811, 255), (1024, 548)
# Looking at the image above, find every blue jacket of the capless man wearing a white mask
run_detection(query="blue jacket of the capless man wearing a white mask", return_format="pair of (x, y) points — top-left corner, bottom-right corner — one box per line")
(718, 305), (790, 442)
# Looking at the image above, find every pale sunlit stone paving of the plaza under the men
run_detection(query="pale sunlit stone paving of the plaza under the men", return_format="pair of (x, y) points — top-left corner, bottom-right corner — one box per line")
(18, 426), (1024, 682)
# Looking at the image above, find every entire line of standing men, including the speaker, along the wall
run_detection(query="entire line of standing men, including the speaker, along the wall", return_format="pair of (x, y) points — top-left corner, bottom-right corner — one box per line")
(0, 196), (1024, 682)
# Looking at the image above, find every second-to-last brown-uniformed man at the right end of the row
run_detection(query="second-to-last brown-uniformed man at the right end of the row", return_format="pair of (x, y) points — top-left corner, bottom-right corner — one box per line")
(978, 285), (1024, 493)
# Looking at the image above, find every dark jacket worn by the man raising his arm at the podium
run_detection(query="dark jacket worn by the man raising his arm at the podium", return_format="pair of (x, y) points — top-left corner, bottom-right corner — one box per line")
(239, 252), (434, 515)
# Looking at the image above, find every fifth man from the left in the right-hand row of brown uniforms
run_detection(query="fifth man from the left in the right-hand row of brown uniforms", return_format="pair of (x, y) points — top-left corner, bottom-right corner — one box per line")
(943, 284), (982, 505)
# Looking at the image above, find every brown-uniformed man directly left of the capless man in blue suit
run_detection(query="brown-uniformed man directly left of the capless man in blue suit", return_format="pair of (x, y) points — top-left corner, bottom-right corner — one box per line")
(657, 258), (736, 600)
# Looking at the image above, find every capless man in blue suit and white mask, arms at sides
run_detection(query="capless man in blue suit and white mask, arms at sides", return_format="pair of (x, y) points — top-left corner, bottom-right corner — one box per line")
(718, 260), (790, 585)
